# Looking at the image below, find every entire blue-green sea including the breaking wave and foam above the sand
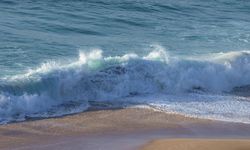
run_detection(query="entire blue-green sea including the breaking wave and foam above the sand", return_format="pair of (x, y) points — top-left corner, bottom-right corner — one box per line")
(0, 0), (250, 124)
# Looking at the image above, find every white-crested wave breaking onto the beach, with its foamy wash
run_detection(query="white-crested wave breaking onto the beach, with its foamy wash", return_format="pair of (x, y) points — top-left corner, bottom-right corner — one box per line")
(0, 47), (250, 123)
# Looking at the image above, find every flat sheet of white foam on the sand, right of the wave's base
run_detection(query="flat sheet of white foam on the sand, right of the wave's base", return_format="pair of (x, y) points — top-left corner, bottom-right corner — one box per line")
(143, 93), (250, 123)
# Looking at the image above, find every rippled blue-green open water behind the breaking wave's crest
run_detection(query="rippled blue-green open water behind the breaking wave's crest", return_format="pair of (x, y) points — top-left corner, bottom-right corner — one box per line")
(0, 0), (250, 76)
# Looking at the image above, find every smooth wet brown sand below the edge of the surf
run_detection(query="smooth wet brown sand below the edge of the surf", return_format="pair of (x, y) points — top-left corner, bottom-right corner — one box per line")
(0, 108), (250, 150)
